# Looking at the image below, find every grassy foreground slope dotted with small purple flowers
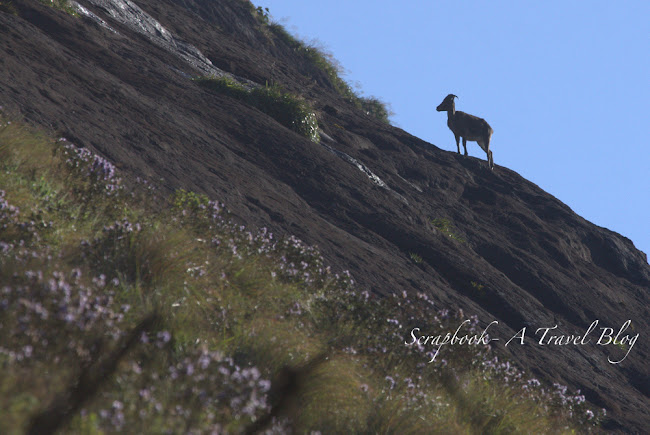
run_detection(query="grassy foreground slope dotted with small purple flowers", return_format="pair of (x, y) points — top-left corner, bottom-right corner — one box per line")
(0, 116), (597, 434)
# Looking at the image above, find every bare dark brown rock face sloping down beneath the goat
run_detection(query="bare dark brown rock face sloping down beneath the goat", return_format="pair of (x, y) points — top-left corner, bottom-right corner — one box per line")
(0, 0), (650, 432)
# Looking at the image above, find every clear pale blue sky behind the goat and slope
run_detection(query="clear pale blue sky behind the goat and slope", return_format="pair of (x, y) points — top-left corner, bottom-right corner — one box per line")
(253, 0), (650, 255)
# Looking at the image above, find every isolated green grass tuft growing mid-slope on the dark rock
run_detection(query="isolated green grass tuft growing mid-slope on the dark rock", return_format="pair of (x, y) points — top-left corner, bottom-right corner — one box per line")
(195, 76), (320, 142)
